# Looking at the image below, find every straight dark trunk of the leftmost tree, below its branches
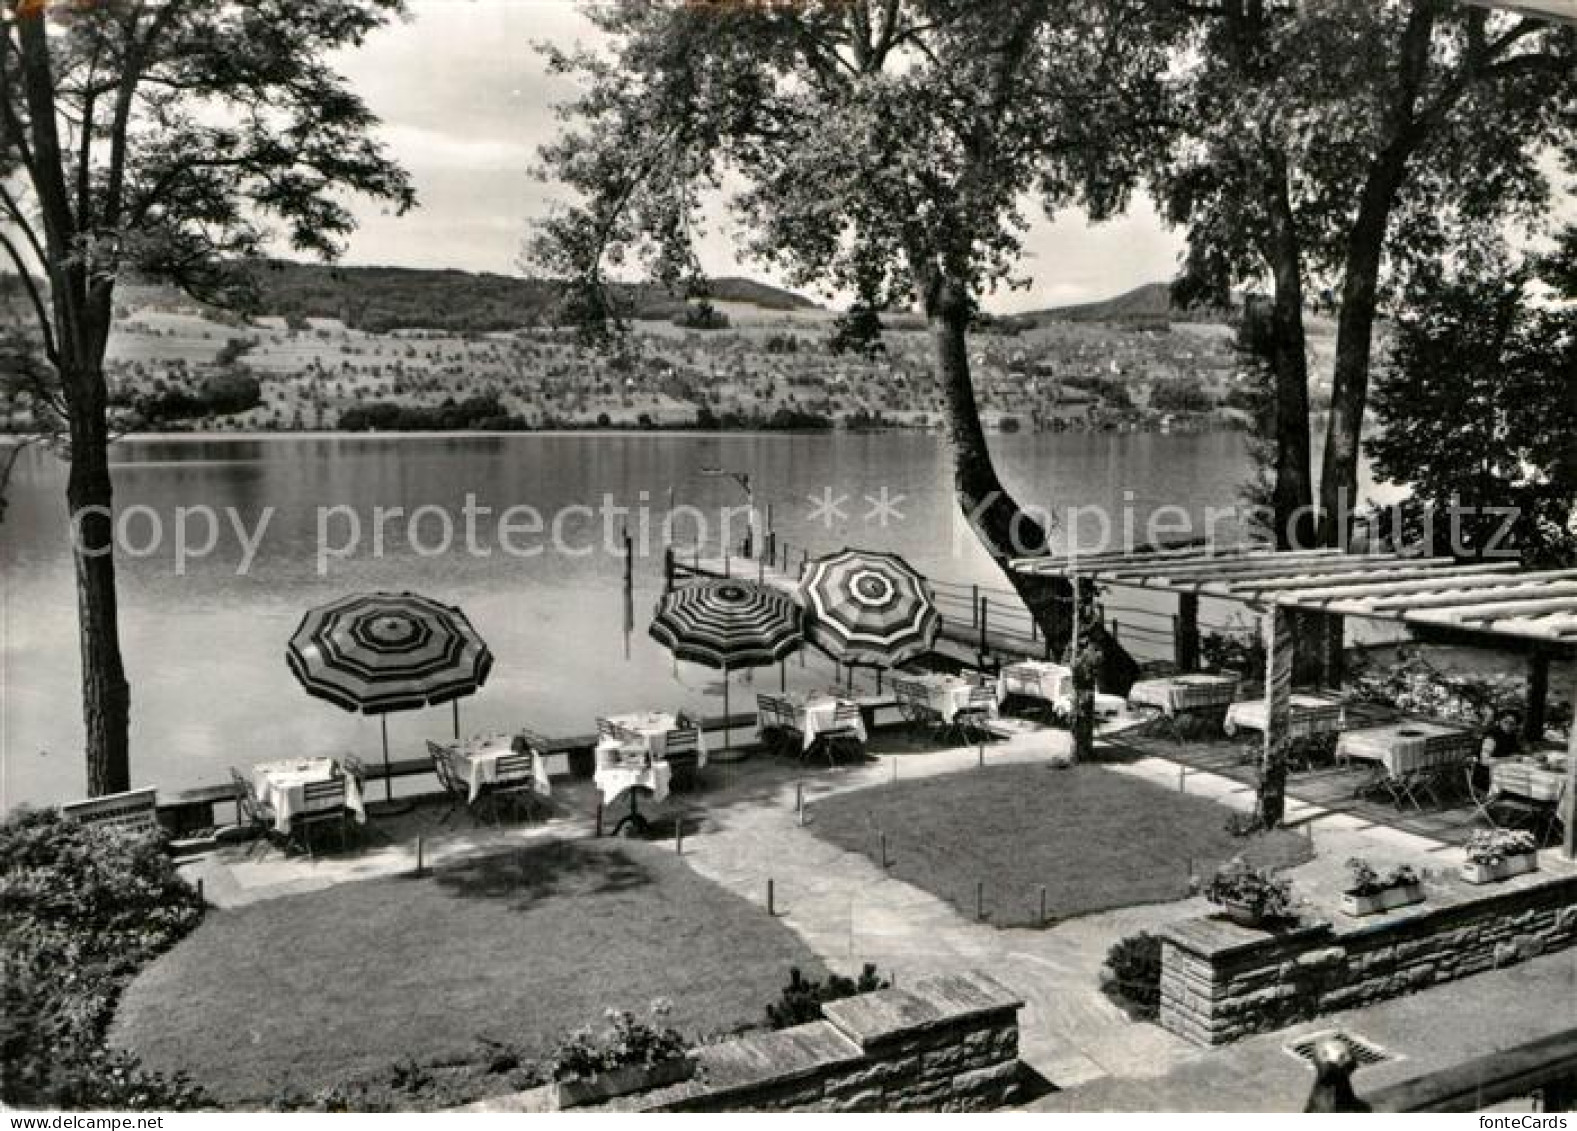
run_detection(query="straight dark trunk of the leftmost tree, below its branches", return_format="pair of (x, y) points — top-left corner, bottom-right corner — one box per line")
(63, 369), (131, 797)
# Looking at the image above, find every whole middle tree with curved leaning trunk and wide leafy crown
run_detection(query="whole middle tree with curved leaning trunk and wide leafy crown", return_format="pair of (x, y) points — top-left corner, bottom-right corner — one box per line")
(531, 0), (1169, 647)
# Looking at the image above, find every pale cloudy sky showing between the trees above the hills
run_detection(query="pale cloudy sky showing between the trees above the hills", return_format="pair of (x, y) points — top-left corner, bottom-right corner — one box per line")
(334, 0), (1183, 312)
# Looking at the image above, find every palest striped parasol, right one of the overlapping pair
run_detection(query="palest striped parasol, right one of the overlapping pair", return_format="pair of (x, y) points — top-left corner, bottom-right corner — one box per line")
(800, 549), (941, 667)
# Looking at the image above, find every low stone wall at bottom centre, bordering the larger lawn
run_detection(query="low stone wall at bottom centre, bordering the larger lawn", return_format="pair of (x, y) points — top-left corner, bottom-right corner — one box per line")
(462, 973), (1023, 1112)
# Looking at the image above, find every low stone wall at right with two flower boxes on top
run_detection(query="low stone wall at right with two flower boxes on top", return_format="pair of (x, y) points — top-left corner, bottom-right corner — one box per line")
(1159, 871), (1577, 1044)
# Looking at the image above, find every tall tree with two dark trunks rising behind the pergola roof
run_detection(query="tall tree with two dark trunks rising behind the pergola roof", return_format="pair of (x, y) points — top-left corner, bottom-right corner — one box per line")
(1156, 0), (1577, 544)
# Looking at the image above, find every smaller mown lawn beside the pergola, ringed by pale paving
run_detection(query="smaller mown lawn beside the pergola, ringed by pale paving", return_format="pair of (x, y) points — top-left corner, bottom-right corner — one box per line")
(809, 765), (1309, 926)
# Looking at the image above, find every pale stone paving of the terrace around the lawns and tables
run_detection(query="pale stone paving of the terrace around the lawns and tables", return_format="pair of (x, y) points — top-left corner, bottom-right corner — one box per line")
(178, 727), (1577, 1110)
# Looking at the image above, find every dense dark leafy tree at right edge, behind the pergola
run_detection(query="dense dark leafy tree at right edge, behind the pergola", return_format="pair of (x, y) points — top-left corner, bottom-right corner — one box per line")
(1364, 247), (1577, 568)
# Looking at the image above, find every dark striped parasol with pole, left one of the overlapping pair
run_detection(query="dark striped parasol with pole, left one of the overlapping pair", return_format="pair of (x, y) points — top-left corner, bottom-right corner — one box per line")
(651, 579), (804, 745)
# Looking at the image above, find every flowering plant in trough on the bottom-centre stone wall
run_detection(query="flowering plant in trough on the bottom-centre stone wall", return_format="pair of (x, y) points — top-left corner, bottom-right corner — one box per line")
(549, 1002), (695, 1109)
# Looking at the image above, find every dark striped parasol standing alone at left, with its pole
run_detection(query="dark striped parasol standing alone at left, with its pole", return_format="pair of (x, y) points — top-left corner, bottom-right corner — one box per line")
(285, 593), (492, 804)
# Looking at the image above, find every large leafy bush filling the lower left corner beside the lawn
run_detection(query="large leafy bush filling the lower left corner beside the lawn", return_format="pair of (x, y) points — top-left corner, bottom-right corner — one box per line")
(0, 809), (203, 1110)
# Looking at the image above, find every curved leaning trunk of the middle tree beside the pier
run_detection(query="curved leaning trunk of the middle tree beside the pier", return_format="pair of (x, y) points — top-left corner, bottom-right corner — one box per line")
(926, 278), (1072, 656)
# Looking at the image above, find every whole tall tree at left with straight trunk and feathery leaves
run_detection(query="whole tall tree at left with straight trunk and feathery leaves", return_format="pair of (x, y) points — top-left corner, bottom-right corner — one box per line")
(0, 0), (413, 793)
